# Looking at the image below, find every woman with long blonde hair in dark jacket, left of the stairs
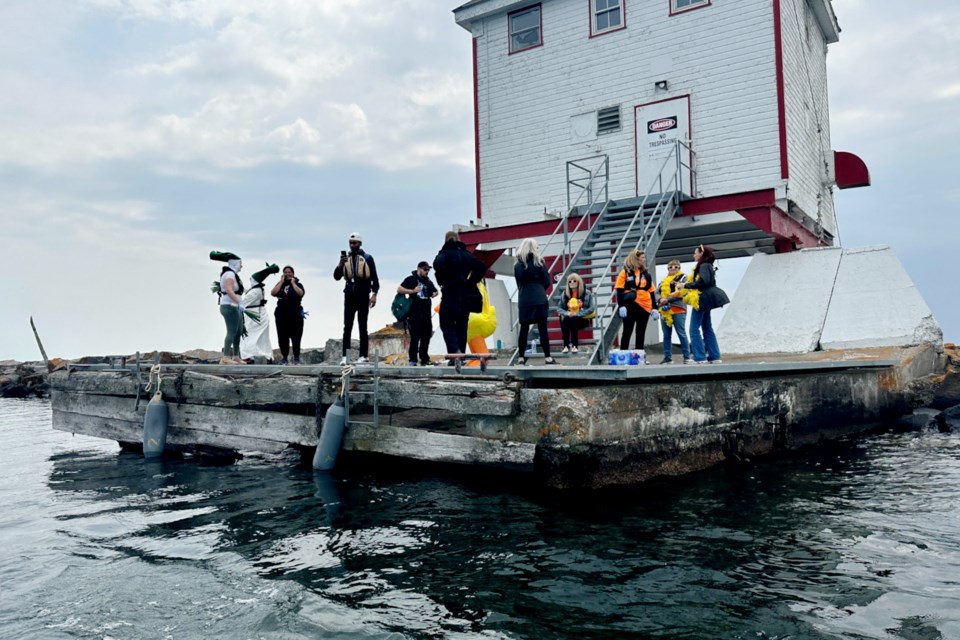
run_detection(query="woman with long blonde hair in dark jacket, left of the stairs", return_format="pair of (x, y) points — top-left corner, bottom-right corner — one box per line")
(513, 238), (556, 365)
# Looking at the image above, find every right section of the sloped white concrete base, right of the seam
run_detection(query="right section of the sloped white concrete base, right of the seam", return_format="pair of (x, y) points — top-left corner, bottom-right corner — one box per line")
(820, 246), (943, 350)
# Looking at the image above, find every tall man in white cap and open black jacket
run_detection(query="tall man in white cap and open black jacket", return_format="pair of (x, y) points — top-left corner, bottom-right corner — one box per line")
(333, 233), (380, 366)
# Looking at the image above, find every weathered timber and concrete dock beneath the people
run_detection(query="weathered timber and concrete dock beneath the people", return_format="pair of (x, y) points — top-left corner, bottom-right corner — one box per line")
(50, 345), (944, 488)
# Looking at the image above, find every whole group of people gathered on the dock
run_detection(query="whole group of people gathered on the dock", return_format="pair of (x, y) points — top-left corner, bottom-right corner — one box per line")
(210, 231), (730, 366)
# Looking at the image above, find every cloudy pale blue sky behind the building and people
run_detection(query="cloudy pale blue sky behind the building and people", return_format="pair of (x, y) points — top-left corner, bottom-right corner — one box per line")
(0, 0), (960, 360)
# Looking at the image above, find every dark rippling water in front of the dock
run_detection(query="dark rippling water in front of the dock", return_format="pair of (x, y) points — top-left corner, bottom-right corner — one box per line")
(0, 400), (960, 640)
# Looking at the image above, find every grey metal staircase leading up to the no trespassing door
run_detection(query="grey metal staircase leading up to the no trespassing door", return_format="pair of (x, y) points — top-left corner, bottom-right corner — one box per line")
(510, 141), (693, 364)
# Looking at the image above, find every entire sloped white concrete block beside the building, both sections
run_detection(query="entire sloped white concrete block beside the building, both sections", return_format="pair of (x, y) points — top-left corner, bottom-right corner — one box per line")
(717, 246), (943, 354)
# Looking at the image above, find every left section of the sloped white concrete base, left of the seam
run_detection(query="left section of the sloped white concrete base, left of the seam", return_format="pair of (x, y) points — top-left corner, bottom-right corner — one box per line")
(717, 248), (843, 353)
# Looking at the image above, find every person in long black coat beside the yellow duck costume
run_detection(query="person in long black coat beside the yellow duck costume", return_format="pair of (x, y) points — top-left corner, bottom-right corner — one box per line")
(433, 231), (487, 354)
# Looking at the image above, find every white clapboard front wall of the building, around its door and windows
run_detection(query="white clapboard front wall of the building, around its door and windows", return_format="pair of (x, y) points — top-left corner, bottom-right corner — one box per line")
(474, 0), (780, 225)
